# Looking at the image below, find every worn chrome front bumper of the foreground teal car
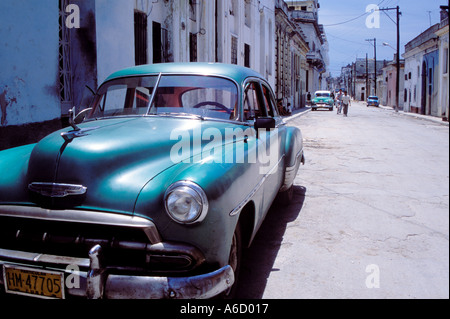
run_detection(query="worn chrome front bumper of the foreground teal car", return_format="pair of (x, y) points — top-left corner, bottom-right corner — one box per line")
(0, 245), (234, 299)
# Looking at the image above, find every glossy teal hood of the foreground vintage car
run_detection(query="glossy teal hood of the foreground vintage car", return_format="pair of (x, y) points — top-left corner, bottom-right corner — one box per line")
(23, 117), (243, 212)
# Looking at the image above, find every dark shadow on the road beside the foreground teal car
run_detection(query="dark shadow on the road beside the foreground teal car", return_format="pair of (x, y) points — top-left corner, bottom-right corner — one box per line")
(236, 186), (306, 299)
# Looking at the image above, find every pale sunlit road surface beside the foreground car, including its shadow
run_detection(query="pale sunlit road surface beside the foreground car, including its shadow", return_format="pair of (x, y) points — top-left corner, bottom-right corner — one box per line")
(237, 103), (449, 299)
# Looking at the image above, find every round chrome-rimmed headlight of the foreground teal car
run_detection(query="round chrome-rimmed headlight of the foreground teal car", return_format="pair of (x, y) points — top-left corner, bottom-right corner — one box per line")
(164, 181), (209, 224)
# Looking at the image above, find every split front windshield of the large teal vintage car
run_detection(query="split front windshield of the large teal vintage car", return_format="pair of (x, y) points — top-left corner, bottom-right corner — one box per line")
(88, 75), (238, 120)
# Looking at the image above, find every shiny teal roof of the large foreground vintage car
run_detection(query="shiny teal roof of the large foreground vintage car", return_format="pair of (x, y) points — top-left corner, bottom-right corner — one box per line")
(105, 62), (264, 83)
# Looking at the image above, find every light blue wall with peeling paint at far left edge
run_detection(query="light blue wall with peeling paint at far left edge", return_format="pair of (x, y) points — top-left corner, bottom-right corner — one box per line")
(0, 0), (61, 126)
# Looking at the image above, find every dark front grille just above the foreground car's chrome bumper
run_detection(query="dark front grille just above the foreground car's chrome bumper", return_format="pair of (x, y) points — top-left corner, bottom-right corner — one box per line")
(0, 216), (204, 274)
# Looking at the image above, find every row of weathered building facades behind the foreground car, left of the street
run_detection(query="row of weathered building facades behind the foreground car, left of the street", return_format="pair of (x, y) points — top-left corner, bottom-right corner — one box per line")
(0, 0), (326, 135)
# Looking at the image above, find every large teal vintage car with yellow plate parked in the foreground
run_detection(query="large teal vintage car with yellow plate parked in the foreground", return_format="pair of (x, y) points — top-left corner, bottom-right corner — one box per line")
(0, 63), (304, 299)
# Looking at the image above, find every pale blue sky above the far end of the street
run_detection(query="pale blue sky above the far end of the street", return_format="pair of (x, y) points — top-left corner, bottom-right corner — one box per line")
(319, 0), (448, 76)
